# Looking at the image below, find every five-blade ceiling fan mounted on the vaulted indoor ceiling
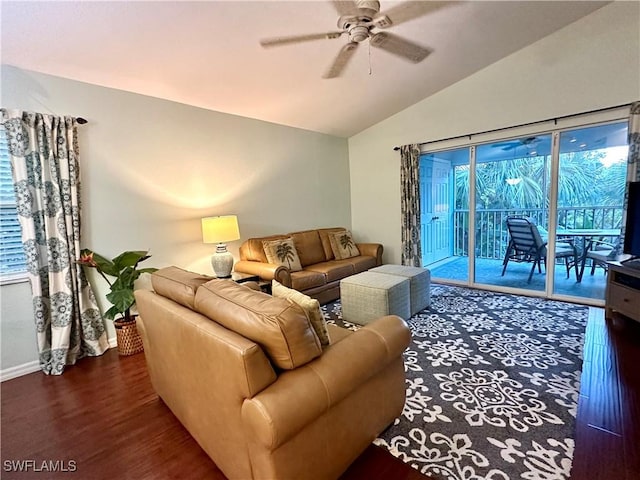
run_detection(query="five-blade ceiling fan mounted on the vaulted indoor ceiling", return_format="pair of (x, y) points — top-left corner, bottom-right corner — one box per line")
(260, 0), (442, 78)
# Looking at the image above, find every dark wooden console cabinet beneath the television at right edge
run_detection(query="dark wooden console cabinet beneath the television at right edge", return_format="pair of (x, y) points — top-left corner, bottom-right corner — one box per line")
(604, 262), (640, 322)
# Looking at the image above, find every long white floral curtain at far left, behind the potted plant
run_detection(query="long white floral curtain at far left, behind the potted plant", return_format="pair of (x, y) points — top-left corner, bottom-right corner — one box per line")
(0, 109), (109, 375)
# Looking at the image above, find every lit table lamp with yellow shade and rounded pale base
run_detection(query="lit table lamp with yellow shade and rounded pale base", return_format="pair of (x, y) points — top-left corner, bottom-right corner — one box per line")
(202, 215), (240, 278)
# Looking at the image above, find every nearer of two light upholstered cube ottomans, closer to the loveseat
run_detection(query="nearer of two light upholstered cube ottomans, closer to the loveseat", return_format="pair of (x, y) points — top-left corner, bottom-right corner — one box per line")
(340, 271), (411, 325)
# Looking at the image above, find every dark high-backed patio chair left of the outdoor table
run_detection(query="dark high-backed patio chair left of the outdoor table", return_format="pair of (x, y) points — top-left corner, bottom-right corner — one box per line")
(502, 216), (579, 283)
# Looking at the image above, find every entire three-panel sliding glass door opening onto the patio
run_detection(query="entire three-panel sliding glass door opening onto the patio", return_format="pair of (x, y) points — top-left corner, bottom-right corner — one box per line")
(421, 122), (627, 300)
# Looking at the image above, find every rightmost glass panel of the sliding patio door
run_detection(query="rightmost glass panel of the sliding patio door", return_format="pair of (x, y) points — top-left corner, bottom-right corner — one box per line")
(553, 122), (628, 299)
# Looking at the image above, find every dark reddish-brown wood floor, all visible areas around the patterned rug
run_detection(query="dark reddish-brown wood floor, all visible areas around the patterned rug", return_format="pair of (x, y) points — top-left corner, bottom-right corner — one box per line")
(0, 309), (640, 480)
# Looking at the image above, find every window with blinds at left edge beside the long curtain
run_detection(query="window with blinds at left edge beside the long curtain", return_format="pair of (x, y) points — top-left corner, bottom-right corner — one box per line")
(0, 127), (27, 282)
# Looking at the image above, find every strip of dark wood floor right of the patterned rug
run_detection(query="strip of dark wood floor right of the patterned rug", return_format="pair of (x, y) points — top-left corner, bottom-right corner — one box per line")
(571, 309), (640, 480)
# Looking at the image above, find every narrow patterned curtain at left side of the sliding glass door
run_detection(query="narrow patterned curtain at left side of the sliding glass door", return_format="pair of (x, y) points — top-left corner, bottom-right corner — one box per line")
(400, 145), (422, 267)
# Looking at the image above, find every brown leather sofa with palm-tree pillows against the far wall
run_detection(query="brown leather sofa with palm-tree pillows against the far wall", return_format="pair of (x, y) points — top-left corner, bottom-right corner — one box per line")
(234, 227), (383, 303)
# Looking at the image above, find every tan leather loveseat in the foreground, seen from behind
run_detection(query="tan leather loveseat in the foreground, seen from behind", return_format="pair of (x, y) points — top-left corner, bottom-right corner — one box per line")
(135, 267), (410, 480)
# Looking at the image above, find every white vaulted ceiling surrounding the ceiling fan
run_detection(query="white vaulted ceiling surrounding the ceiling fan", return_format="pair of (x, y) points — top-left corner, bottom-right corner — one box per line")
(0, 0), (609, 137)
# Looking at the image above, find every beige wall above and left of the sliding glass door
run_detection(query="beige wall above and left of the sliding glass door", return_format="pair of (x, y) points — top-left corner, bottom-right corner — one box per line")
(349, 2), (640, 263)
